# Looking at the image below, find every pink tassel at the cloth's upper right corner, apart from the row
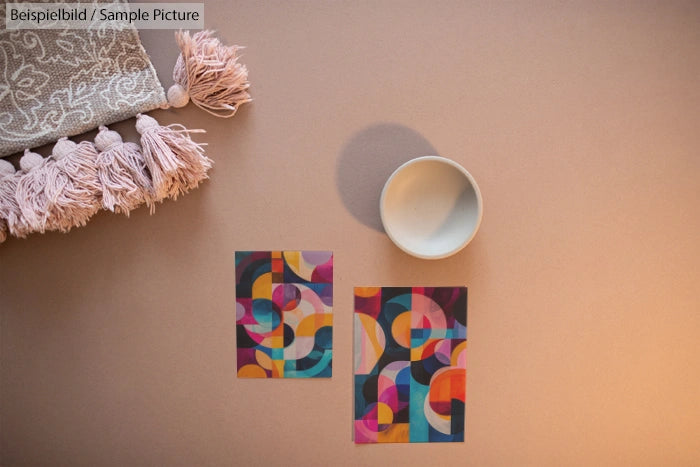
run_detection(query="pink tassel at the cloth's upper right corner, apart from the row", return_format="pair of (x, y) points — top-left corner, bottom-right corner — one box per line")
(168, 31), (251, 117)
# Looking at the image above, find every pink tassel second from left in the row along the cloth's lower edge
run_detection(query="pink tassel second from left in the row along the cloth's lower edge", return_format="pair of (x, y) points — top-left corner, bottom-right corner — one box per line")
(14, 149), (62, 237)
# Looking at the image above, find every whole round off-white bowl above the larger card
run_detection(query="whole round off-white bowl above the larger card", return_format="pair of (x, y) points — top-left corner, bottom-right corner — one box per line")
(380, 156), (482, 258)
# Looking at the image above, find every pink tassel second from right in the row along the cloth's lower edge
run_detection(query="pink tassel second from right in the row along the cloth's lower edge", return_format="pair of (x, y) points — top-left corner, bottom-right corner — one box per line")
(95, 126), (155, 217)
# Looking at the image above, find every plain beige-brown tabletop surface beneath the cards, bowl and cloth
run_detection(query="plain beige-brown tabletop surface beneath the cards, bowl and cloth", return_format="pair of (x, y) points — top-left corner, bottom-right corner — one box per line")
(0, 1), (700, 466)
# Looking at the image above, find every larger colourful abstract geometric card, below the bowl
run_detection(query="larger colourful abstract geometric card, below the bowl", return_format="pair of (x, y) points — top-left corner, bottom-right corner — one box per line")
(355, 287), (467, 444)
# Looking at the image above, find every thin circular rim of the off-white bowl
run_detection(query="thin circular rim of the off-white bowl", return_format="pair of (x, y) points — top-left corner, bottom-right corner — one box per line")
(379, 156), (484, 259)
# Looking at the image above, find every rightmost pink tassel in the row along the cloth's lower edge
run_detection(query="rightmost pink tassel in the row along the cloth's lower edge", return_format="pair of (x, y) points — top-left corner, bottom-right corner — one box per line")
(136, 114), (213, 201)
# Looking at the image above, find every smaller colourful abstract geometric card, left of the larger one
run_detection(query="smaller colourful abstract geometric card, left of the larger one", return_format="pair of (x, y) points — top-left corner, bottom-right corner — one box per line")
(236, 251), (333, 378)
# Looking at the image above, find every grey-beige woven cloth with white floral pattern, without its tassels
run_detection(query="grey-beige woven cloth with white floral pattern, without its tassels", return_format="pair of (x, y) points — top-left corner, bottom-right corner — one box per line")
(0, 0), (166, 157)
